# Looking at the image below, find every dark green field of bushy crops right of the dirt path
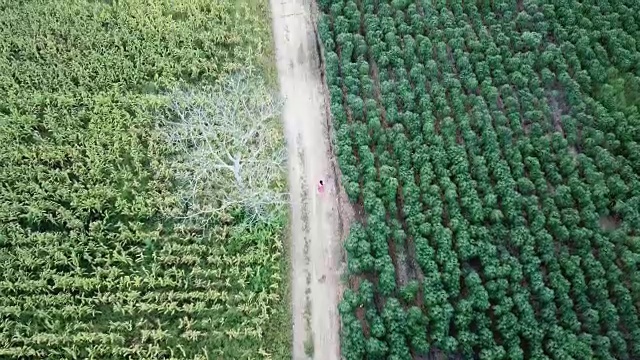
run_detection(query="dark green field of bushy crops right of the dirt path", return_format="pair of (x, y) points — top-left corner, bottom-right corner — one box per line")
(318, 0), (640, 360)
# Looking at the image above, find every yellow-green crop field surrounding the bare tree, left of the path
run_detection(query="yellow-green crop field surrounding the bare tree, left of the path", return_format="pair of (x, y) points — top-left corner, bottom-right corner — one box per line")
(0, 0), (291, 359)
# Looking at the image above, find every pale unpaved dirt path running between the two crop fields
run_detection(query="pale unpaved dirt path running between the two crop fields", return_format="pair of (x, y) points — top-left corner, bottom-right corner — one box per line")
(270, 0), (341, 360)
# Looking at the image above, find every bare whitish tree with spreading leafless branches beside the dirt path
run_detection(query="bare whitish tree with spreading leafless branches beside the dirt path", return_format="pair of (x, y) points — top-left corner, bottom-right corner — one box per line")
(160, 70), (289, 224)
